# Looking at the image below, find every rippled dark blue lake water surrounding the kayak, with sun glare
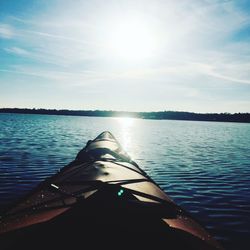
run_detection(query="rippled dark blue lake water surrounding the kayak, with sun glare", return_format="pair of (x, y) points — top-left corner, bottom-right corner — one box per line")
(0, 114), (250, 249)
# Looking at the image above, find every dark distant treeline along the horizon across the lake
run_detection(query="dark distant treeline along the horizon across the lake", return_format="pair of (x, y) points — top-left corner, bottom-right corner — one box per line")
(0, 108), (250, 123)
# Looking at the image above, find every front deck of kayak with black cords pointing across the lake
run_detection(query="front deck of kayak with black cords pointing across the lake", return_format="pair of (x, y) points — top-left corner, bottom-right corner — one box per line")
(0, 131), (222, 250)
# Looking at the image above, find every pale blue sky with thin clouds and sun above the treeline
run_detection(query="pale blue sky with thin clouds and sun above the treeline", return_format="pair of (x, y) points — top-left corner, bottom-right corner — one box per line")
(0, 0), (250, 113)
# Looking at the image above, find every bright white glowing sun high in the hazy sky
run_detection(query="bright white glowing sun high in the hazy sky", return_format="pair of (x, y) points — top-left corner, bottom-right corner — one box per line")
(105, 17), (156, 61)
